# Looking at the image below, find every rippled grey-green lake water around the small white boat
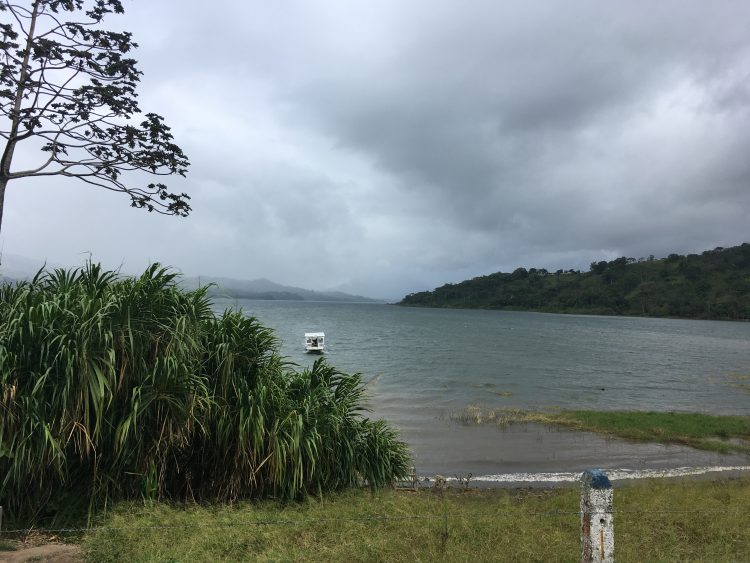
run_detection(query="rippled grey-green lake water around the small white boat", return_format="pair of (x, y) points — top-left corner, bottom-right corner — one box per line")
(217, 300), (750, 480)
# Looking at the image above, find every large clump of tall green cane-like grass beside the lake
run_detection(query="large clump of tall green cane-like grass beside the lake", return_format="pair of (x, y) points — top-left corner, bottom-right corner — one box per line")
(0, 263), (409, 520)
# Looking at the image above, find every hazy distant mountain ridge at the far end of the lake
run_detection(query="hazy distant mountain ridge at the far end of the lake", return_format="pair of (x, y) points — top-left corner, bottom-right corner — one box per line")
(180, 276), (381, 303)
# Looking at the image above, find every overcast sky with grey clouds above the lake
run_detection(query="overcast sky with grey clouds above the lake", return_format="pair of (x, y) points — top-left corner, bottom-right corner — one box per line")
(0, 0), (750, 298)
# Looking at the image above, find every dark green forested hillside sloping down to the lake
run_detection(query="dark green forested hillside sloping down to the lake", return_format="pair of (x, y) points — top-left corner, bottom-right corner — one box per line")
(399, 243), (750, 319)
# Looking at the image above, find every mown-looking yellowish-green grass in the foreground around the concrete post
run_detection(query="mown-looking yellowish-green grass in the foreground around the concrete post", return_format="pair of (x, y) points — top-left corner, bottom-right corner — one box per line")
(0, 478), (724, 562)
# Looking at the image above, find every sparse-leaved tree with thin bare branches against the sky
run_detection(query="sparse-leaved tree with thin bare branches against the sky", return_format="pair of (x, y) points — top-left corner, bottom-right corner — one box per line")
(0, 0), (190, 234)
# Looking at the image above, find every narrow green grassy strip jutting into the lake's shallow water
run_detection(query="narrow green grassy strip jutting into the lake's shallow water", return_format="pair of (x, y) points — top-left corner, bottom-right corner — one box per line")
(451, 407), (750, 454)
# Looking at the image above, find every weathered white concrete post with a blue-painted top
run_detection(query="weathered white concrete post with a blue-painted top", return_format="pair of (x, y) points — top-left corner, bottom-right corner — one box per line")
(581, 469), (615, 563)
